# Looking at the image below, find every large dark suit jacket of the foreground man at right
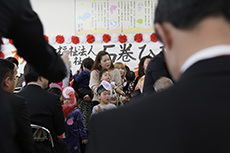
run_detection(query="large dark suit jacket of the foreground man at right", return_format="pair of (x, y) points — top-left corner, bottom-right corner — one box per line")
(88, 56), (230, 153)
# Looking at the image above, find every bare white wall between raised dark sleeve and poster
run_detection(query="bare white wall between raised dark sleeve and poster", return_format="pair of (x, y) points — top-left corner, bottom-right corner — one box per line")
(30, 0), (75, 36)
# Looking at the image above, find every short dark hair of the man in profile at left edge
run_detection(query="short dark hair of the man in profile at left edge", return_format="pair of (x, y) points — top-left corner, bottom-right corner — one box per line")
(0, 58), (14, 83)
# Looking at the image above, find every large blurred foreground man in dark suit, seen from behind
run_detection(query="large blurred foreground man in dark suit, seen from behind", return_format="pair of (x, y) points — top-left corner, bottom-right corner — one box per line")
(88, 0), (230, 153)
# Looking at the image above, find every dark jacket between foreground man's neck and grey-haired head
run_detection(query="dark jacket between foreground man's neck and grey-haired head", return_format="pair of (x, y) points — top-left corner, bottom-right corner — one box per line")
(143, 52), (171, 94)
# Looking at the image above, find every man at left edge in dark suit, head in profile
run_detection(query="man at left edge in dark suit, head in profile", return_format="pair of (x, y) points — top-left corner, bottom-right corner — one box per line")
(0, 59), (33, 153)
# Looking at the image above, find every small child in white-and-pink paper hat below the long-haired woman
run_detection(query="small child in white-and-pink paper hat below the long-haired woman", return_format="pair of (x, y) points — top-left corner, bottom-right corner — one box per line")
(92, 81), (116, 115)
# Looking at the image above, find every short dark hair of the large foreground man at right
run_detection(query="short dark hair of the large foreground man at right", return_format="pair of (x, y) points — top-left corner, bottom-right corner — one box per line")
(154, 0), (230, 29)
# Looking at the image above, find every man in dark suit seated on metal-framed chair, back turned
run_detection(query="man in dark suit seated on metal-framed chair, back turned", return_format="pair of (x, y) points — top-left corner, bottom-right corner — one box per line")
(19, 64), (66, 153)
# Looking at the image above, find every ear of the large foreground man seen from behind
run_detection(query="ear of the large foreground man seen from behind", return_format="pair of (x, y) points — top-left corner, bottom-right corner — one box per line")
(155, 23), (172, 50)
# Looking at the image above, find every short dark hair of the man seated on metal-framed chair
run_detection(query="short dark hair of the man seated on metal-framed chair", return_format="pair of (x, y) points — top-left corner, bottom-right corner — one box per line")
(24, 63), (41, 83)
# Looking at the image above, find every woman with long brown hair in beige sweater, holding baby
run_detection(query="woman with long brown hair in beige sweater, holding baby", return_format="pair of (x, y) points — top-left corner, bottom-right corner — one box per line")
(89, 51), (122, 104)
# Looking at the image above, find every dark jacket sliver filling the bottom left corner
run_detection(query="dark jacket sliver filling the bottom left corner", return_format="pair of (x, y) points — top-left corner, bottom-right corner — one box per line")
(0, 87), (19, 153)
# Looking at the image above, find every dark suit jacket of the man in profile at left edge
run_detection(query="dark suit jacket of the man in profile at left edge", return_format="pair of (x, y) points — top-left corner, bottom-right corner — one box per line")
(8, 93), (34, 153)
